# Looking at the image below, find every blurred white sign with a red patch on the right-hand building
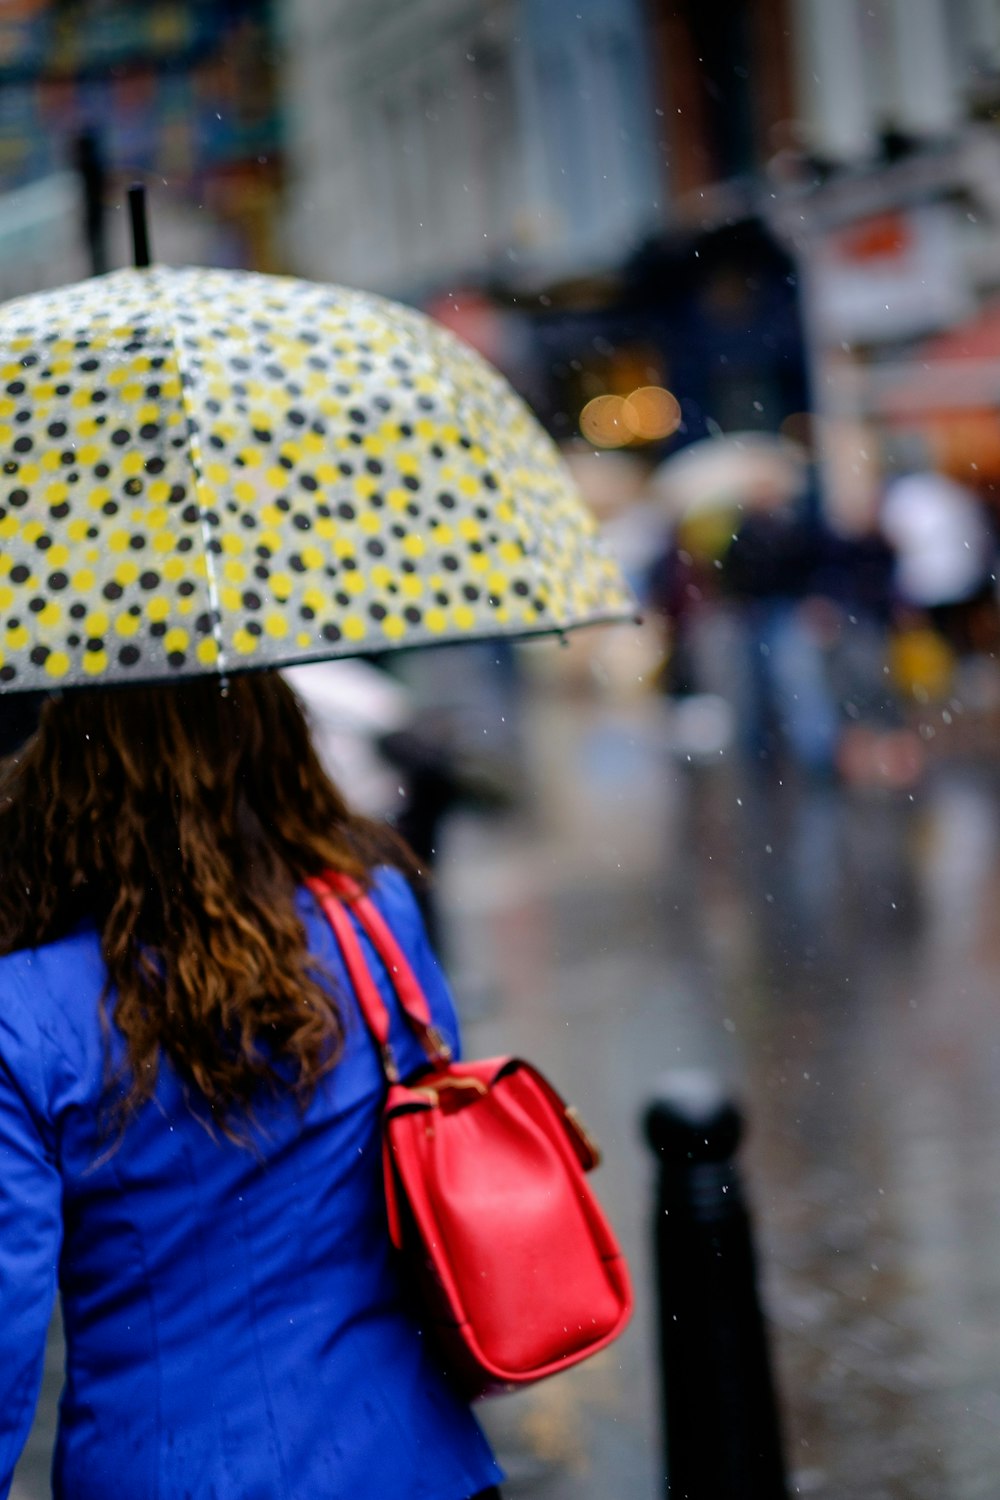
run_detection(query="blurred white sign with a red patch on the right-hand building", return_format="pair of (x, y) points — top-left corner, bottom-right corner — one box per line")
(814, 204), (973, 344)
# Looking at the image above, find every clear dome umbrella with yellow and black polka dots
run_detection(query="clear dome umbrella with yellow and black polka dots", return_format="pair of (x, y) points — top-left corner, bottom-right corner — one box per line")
(0, 267), (634, 692)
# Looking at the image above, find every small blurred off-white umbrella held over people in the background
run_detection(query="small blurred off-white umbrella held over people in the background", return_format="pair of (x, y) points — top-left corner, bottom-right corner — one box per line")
(652, 432), (807, 519)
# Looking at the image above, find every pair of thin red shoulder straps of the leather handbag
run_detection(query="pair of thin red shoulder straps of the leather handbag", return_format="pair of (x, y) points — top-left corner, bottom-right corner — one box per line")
(306, 870), (451, 1083)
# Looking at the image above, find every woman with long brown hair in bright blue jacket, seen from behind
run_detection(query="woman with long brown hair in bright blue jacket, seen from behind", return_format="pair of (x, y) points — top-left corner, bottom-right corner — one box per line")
(0, 674), (501, 1500)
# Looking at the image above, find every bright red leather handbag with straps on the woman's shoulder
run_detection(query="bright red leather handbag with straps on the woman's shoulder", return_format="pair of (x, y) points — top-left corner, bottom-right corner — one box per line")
(307, 872), (633, 1400)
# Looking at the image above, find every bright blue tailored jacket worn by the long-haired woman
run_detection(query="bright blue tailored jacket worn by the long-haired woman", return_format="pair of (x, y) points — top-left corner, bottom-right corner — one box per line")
(0, 870), (499, 1500)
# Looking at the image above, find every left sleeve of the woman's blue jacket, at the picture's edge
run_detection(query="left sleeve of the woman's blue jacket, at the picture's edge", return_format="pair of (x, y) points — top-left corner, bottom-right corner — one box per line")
(0, 977), (61, 1500)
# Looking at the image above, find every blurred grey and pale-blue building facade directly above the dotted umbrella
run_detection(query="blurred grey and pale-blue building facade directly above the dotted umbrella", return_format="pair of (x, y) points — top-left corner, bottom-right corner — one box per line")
(282, 0), (661, 296)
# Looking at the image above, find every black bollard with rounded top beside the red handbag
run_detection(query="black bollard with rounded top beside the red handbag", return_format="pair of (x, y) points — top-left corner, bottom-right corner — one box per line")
(645, 1073), (787, 1500)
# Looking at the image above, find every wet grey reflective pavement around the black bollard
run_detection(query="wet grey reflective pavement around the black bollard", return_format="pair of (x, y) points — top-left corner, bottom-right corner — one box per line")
(15, 675), (1000, 1500)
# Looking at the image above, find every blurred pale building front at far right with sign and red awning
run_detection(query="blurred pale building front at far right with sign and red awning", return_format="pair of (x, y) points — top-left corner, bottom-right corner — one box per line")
(769, 0), (1000, 524)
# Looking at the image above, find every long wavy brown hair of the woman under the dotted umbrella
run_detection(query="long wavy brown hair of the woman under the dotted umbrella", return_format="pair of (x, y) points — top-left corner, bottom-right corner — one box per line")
(0, 672), (406, 1139)
